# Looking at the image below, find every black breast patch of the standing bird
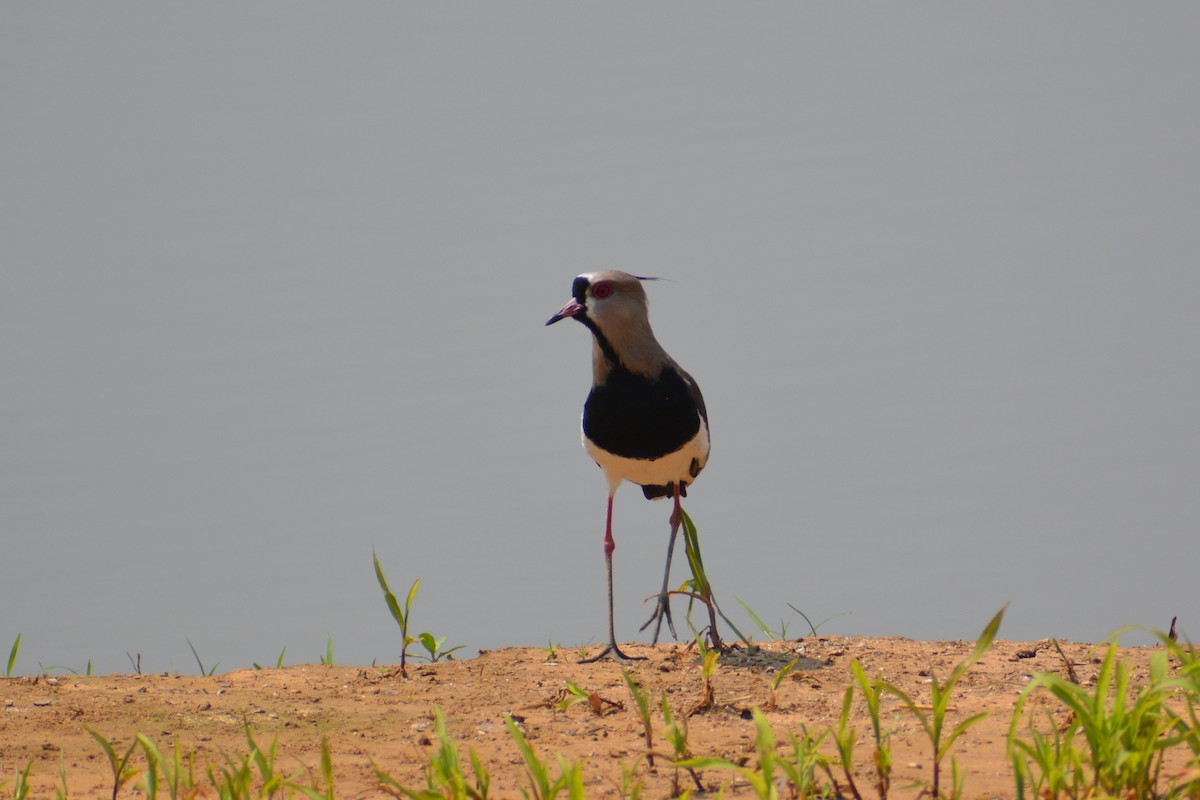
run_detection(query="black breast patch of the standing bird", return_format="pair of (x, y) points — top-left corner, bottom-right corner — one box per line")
(583, 365), (700, 458)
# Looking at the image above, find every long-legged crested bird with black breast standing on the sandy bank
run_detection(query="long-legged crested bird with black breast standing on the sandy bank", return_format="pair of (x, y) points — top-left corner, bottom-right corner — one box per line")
(546, 270), (710, 663)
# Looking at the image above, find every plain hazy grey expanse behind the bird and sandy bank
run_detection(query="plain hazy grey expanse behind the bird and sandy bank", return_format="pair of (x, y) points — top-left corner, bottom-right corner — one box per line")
(0, 2), (1200, 672)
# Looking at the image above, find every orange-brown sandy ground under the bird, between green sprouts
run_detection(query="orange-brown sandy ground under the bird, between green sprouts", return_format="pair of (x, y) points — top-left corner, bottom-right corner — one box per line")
(0, 637), (1180, 798)
